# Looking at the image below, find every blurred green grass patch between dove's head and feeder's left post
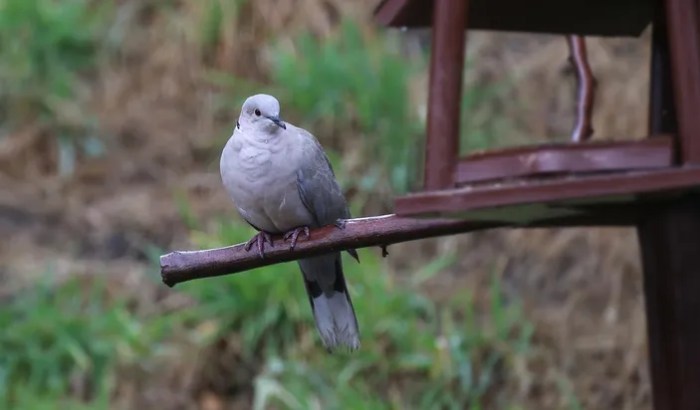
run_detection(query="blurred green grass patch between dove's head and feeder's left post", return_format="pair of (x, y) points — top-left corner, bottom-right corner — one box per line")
(272, 21), (421, 191)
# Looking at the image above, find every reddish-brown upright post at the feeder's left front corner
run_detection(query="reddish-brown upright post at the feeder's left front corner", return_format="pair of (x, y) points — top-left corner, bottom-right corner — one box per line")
(423, 0), (469, 189)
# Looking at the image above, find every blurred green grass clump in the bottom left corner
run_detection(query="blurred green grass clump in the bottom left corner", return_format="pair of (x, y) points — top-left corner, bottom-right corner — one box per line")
(0, 278), (161, 408)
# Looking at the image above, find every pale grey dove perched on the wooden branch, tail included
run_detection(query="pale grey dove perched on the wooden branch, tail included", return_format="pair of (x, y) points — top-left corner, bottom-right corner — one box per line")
(220, 94), (360, 351)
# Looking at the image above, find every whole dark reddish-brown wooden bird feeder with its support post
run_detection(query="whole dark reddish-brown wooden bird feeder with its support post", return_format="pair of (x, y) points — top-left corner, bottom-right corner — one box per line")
(376, 0), (700, 410)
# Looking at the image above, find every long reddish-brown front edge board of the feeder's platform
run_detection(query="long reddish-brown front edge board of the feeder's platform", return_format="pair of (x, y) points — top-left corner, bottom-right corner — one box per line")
(395, 167), (700, 216)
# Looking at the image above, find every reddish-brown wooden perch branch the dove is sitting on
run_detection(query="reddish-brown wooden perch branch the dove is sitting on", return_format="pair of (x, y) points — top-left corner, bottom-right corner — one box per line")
(160, 214), (503, 287)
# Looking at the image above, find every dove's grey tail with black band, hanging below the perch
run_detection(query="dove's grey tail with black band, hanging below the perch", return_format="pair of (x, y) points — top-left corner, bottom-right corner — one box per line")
(299, 253), (360, 351)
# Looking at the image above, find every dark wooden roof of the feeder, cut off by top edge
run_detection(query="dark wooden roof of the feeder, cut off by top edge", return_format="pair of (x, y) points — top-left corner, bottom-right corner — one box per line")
(375, 0), (652, 37)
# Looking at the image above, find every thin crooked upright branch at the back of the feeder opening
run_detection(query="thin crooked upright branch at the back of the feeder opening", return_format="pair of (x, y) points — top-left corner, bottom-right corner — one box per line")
(566, 35), (596, 142)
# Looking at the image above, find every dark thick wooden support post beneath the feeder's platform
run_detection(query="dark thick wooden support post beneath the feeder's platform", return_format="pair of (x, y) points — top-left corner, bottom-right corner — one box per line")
(638, 198), (700, 410)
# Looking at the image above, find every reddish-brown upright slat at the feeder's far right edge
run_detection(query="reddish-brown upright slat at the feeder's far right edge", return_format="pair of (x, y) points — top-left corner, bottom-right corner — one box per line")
(665, 0), (700, 164)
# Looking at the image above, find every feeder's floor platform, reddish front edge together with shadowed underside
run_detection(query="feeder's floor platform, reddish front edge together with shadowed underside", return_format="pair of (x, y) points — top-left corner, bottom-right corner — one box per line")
(395, 167), (700, 226)
